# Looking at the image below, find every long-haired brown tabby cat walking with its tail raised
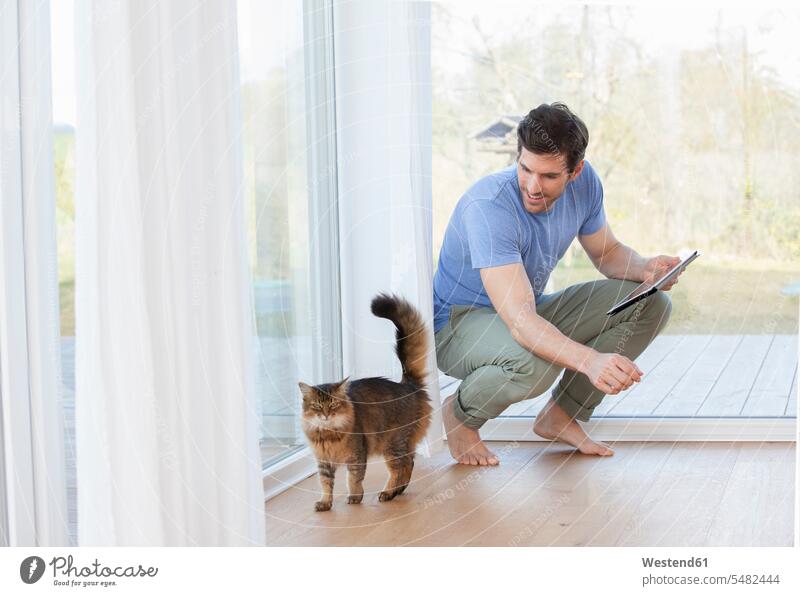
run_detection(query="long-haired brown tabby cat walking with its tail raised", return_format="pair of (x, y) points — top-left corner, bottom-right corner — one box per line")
(299, 294), (432, 511)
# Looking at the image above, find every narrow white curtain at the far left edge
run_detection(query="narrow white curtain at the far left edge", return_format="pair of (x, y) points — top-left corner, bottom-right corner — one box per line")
(0, 0), (69, 546)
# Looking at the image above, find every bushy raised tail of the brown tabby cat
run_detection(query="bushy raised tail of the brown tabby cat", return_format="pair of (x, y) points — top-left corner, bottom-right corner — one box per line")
(372, 294), (428, 388)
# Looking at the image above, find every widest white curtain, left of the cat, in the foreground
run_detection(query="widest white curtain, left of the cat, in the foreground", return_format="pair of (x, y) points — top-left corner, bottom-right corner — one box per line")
(76, 0), (264, 546)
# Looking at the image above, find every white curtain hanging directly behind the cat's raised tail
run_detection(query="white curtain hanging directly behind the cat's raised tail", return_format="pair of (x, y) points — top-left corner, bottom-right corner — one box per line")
(334, 0), (442, 450)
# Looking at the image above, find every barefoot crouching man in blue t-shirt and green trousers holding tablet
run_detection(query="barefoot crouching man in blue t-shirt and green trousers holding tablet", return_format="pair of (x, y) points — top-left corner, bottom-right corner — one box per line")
(433, 103), (679, 465)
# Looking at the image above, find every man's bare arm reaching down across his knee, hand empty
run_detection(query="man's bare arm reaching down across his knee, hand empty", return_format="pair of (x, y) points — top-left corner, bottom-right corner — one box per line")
(480, 263), (643, 394)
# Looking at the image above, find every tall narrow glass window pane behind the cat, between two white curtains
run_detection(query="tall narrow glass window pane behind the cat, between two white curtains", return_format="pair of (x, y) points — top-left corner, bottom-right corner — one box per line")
(234, 0), (341, 465)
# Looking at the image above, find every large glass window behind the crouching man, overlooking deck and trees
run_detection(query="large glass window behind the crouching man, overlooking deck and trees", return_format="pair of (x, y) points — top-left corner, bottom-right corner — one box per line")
(432, 3), (800, 426)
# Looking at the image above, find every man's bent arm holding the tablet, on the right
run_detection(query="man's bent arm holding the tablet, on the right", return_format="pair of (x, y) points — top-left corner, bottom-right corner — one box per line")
(578, 224), (680, 291)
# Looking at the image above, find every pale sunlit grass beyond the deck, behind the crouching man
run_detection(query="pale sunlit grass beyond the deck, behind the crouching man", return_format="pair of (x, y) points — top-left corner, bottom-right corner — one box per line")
(553, 262), (800, 335)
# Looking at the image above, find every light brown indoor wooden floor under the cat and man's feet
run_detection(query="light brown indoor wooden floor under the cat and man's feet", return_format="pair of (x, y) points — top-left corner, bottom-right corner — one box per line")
(266, 443), (795, 546)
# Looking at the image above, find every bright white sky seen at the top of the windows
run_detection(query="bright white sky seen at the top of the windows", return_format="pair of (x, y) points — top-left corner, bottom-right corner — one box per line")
(50, 0), (800, 124)
